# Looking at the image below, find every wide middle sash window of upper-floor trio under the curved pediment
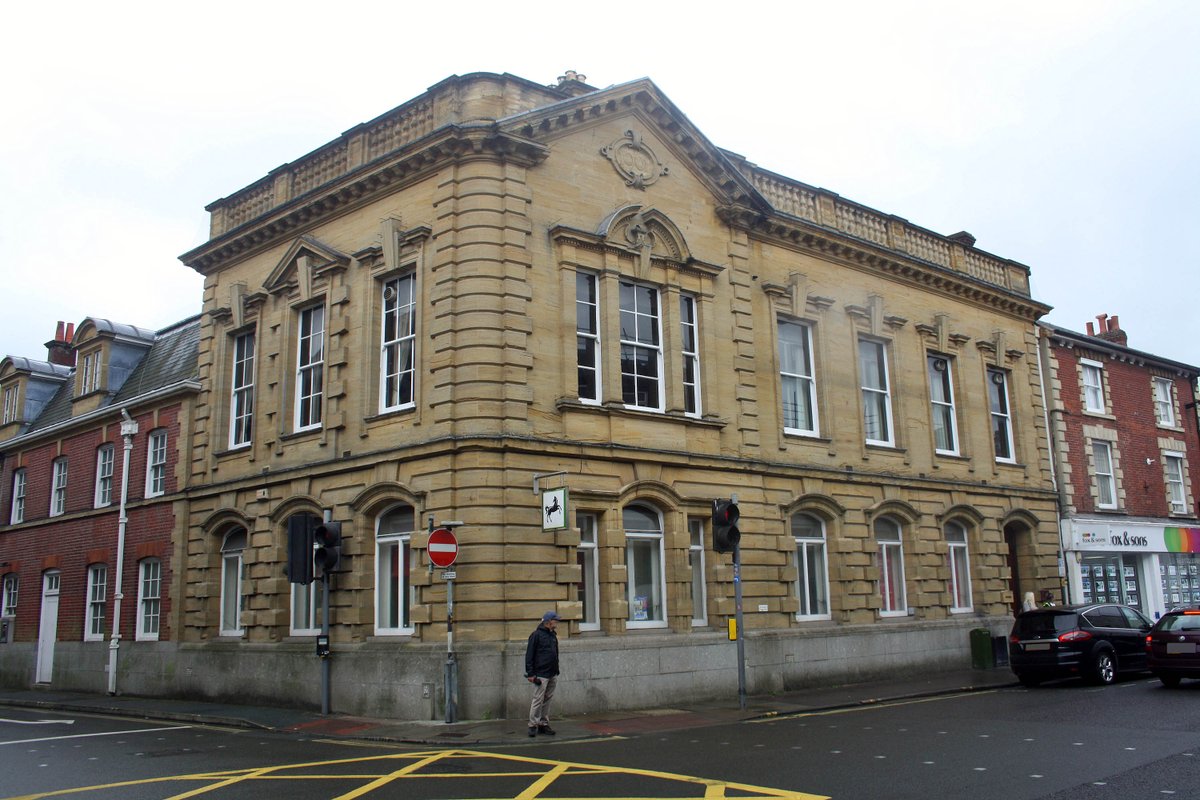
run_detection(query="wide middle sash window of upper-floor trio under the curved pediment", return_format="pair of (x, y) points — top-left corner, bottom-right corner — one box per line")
(620, 281), (664, 411)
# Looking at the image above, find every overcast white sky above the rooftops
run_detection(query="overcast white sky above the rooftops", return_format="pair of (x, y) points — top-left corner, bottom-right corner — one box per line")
(0, 0), (1200, 366)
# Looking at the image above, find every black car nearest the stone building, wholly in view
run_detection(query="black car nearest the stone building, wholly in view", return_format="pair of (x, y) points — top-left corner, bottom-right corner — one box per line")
(1008, 603), (1151, 686)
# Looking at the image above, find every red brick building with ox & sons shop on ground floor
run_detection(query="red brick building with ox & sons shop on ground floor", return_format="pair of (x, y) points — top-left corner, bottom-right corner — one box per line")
(1039, 314), (1200, 615)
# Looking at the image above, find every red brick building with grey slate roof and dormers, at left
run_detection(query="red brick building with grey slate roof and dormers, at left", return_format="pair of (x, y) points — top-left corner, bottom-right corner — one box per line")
(0, 318), (199, 692)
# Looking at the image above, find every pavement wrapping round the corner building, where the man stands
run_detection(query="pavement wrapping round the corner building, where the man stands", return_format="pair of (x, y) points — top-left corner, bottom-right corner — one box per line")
(0, 667), (1016, 747)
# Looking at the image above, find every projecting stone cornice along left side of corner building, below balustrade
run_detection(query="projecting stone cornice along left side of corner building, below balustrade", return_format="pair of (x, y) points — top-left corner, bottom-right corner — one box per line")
(180, 124), (550, 275)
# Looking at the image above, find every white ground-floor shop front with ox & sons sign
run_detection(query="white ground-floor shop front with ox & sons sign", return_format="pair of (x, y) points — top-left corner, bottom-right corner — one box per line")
(1063, 519), (1200, 618)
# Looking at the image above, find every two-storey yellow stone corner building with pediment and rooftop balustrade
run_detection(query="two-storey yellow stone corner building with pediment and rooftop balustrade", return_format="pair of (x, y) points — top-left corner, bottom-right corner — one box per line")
(174, 73), (1058, 717)
